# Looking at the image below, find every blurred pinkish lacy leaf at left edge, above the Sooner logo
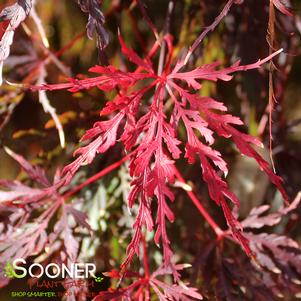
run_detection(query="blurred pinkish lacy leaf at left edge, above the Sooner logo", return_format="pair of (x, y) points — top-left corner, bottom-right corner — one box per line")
(0, 148), (92, 263)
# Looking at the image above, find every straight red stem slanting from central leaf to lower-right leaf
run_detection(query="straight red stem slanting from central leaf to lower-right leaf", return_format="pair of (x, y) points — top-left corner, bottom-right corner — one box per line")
(174, 166), (225, 237)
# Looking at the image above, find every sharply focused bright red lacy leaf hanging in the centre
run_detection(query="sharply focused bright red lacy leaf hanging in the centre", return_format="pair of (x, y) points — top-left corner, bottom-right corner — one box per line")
(34, 33), (288, 269)
